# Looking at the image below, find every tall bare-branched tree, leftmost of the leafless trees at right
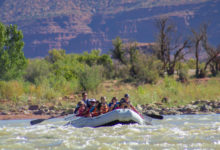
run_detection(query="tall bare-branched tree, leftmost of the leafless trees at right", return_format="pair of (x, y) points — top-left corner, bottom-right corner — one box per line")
(154, 17), (191, 75)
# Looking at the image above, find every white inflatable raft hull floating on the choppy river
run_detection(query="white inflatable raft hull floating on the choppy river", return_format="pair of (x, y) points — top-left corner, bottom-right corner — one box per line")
(70, 109), (146, 128)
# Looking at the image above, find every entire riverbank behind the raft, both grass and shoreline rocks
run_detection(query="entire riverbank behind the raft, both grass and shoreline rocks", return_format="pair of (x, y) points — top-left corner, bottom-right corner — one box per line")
(0, 78), (220, 119)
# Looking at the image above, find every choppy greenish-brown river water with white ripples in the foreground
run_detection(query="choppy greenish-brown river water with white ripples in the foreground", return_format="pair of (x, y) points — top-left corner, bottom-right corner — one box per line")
(0, 115), (220, 150)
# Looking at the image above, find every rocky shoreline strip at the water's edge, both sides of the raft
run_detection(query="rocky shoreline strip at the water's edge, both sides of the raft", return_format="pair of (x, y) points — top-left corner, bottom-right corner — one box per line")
(0, 100), (220, 120)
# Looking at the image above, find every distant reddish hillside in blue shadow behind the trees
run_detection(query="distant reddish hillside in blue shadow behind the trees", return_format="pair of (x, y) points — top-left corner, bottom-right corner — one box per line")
(0, 0), (220, 57)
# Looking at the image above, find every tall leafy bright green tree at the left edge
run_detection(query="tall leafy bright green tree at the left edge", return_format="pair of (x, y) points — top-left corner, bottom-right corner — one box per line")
(0, 23), (27, 80)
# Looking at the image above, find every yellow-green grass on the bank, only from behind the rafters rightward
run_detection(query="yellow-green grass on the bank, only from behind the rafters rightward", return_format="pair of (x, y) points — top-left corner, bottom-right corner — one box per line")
(90, 78), (220, 107)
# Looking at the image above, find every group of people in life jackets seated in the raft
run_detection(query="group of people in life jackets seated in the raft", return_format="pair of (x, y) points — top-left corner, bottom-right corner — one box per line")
(74, 92), (141, 117)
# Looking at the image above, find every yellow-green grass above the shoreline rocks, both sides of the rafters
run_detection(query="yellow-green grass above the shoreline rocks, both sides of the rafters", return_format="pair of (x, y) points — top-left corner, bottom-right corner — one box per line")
(0, 77), (220, 109)
